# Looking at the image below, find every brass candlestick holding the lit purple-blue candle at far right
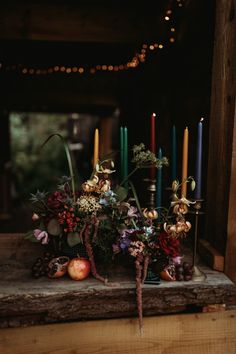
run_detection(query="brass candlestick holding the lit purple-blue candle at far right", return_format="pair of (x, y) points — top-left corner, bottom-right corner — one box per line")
(192, 199), (206, 281)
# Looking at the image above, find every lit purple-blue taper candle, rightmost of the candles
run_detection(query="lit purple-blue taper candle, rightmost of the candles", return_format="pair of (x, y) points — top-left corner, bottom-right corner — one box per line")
(194, 118), (203, 199)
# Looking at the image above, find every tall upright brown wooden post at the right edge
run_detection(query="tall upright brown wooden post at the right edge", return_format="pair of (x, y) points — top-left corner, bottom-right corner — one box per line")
(206, 0), (236, 281)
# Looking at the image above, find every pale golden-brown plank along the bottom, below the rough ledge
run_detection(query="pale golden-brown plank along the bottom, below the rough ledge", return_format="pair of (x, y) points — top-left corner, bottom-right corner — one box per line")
(0, 310), (236, 354)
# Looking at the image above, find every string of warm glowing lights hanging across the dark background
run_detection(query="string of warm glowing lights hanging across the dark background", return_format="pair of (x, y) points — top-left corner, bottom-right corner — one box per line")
(0, 0), (184, 76)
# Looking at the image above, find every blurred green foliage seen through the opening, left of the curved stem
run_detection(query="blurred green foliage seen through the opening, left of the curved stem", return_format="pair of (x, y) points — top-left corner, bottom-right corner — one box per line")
(10, 112), (69, 200)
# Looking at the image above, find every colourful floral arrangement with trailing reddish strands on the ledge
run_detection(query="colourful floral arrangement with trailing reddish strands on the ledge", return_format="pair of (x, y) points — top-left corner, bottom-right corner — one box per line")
(26, 135), (194, 329)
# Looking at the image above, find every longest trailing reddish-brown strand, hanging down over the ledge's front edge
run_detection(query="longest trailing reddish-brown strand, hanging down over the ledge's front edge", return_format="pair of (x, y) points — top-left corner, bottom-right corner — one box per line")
(135, 255), (143, 336)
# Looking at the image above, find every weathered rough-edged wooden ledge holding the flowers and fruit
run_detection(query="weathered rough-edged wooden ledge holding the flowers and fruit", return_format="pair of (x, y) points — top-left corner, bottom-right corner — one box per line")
(0, 235), (236, 328)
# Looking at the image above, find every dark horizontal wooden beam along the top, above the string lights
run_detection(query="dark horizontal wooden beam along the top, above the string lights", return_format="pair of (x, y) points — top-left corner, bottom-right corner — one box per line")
(0, 1), (166, 43)
